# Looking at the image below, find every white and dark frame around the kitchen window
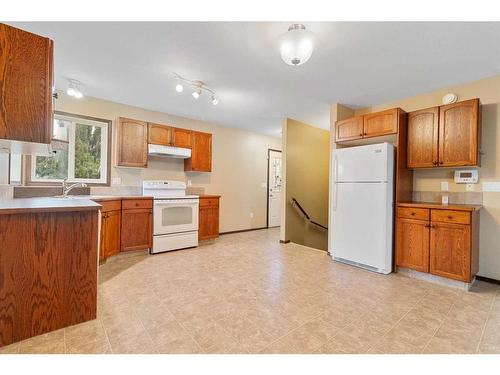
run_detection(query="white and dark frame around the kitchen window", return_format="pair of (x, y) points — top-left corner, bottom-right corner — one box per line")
(25, 111), (113, 186)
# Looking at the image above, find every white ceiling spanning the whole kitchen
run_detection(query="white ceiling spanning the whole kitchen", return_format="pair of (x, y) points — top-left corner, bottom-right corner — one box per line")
(11, 22), (500, 137)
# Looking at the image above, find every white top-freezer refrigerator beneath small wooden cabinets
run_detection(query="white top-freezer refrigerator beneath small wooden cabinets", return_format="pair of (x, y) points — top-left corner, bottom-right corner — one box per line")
(328, 143), (394, 274)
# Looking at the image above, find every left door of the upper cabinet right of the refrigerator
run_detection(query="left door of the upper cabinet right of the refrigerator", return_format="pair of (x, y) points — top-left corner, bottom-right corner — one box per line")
(408, 107), (439, 168)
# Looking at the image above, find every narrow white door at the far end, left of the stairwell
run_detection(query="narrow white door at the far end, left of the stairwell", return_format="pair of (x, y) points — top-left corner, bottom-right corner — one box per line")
(267, 150), (282, 227)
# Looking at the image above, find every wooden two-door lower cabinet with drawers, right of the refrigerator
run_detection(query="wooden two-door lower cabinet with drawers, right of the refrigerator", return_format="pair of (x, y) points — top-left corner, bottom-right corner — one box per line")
(396, 205), (479, 282)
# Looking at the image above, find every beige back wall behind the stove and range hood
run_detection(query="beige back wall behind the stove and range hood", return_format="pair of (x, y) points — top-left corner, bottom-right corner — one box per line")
(56, 95), (281, 232)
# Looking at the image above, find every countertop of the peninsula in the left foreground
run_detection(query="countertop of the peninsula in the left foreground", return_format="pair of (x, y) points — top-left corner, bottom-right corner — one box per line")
(0, 197), (101, 215)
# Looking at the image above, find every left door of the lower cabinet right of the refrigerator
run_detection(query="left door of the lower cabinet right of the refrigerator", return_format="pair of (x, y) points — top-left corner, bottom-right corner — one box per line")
(396, 218), (429, 272)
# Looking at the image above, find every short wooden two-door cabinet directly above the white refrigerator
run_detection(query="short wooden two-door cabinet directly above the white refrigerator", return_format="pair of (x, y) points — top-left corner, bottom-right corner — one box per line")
(335, 108), (406, 142)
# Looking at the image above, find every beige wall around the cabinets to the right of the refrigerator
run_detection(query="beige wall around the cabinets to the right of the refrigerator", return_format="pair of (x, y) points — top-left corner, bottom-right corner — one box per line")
(346, 76), (500, 280)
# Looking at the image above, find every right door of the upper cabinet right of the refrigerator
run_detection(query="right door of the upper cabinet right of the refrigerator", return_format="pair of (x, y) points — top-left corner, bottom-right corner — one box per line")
(439, 99), (480, 167)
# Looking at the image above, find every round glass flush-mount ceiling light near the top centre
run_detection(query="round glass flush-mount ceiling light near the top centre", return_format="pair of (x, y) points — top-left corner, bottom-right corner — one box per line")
(279, 23), (315, 66)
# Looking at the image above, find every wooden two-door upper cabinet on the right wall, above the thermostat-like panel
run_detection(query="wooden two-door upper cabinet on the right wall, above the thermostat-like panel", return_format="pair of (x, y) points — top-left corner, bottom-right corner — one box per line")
(407, 99), (481, 168)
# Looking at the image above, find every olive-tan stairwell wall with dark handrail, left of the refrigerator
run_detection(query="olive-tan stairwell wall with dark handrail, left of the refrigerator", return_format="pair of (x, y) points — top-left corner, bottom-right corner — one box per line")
(283, 119), (330, 250)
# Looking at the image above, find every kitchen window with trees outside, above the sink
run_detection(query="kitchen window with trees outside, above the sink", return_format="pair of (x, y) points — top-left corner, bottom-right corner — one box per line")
(31, 113), (111, 184)
